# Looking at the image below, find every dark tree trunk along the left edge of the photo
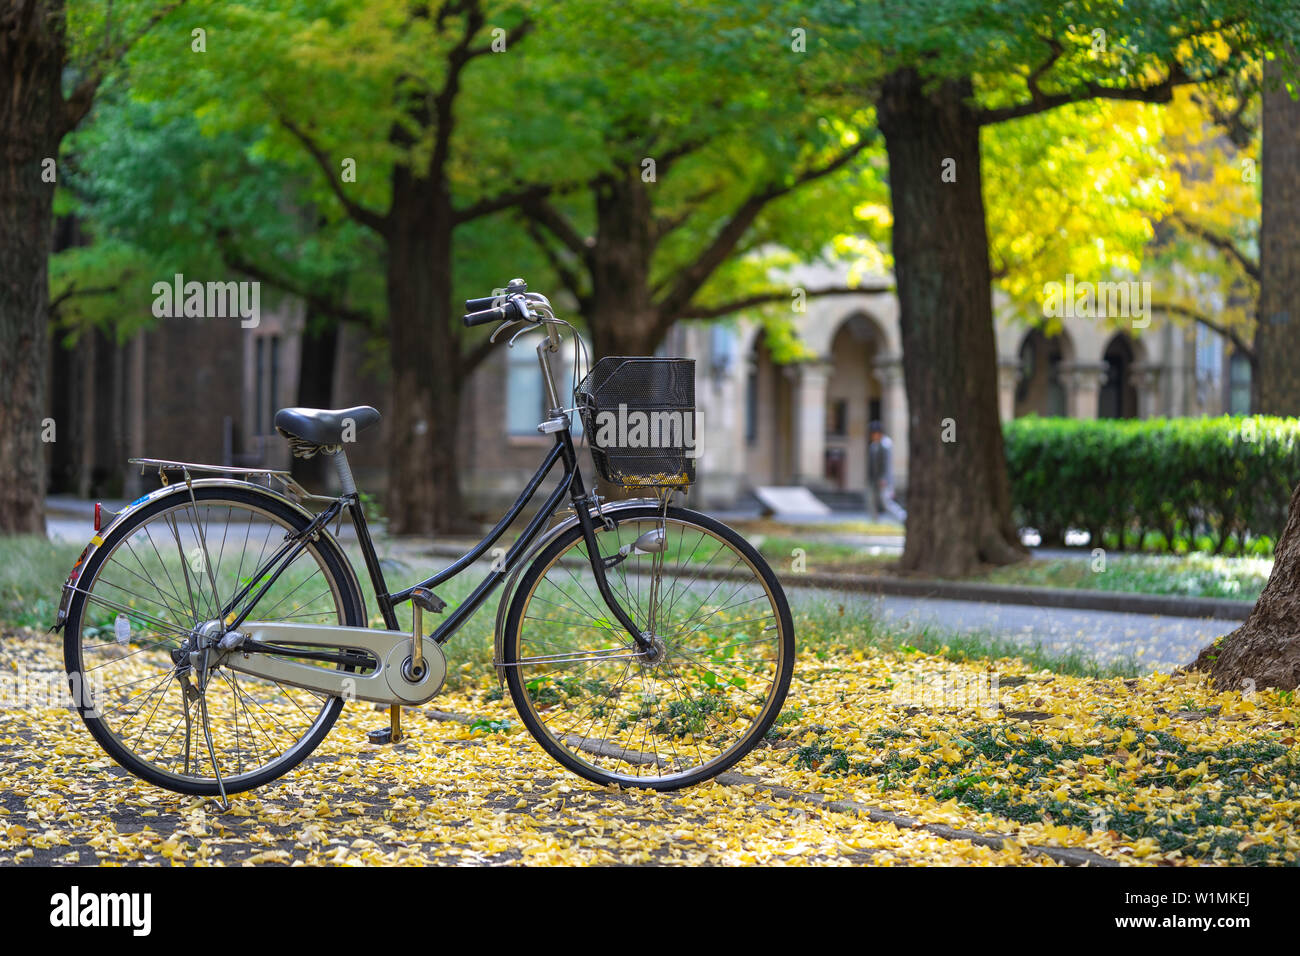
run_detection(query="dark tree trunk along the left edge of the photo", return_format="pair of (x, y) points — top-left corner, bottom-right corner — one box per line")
(0, 0), (66, 535)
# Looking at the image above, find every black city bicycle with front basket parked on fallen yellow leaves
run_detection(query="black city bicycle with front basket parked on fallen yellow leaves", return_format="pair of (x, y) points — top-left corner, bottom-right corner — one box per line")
(55, 280), (794, 805)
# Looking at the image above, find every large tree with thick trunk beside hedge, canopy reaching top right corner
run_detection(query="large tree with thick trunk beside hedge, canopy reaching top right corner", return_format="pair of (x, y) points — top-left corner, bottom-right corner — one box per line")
(806, 0), (1297, 575)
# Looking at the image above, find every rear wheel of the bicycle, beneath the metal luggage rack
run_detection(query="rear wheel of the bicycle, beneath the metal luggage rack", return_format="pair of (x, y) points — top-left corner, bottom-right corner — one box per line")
(64, 484), (365, 796)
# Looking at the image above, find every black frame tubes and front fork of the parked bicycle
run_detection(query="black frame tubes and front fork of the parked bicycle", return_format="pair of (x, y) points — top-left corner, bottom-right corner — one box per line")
(222, 428), (650, 649)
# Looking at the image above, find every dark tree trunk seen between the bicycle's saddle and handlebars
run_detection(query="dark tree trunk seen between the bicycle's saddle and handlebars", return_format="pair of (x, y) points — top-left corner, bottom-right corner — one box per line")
(385, 182), (471, 535)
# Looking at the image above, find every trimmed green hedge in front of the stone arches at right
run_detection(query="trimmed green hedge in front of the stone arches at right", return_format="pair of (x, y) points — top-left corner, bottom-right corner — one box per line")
(1004, 416), (1300, 554)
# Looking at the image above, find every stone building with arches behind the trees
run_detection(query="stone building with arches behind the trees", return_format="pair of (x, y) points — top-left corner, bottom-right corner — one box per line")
(49, 261), (1251, 514)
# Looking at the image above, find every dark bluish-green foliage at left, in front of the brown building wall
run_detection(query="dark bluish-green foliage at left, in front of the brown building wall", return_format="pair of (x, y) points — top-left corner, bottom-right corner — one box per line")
(59, 88), (384, 338)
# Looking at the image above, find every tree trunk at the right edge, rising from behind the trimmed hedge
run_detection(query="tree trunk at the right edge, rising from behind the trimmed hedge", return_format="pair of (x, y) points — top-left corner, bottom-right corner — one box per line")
(1255, 61), (1300, 416)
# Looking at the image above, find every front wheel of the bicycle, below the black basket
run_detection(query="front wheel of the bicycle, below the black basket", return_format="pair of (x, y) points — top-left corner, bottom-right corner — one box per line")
(502, 505), (794, 790)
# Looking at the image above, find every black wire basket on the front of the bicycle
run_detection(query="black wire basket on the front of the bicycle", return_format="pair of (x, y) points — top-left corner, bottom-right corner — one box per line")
(573, 355), (698, 488)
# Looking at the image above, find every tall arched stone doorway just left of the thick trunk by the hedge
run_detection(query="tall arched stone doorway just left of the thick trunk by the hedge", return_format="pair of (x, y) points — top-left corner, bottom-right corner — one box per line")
(823, 312), (883, 492)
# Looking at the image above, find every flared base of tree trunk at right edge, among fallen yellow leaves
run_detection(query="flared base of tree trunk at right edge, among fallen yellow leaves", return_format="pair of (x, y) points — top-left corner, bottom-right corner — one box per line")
(1192, 485), (1300, 691)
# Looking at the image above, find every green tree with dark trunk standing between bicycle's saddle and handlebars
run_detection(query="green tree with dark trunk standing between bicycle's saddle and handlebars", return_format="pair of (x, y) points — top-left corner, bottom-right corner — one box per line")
(126, 0), (569, 533)
